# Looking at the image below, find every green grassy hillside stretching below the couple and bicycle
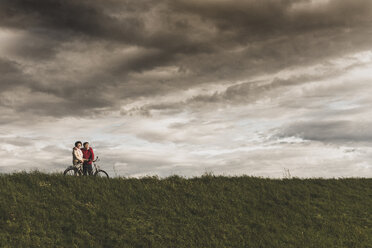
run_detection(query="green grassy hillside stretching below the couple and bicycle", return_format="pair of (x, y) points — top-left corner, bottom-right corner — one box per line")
(0, 172), (372, 248)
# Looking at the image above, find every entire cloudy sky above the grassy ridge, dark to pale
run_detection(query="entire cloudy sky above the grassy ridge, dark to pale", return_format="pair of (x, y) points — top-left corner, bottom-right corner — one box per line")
(0, 0), (372, 177)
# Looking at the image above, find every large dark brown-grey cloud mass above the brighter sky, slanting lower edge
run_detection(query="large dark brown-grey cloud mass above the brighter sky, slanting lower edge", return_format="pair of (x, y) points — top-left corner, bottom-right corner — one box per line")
(0, 0), (372, 116)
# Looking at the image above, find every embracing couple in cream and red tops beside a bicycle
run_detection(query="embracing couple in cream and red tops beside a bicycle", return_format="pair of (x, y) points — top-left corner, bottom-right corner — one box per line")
(72, 141), (94, 176)
